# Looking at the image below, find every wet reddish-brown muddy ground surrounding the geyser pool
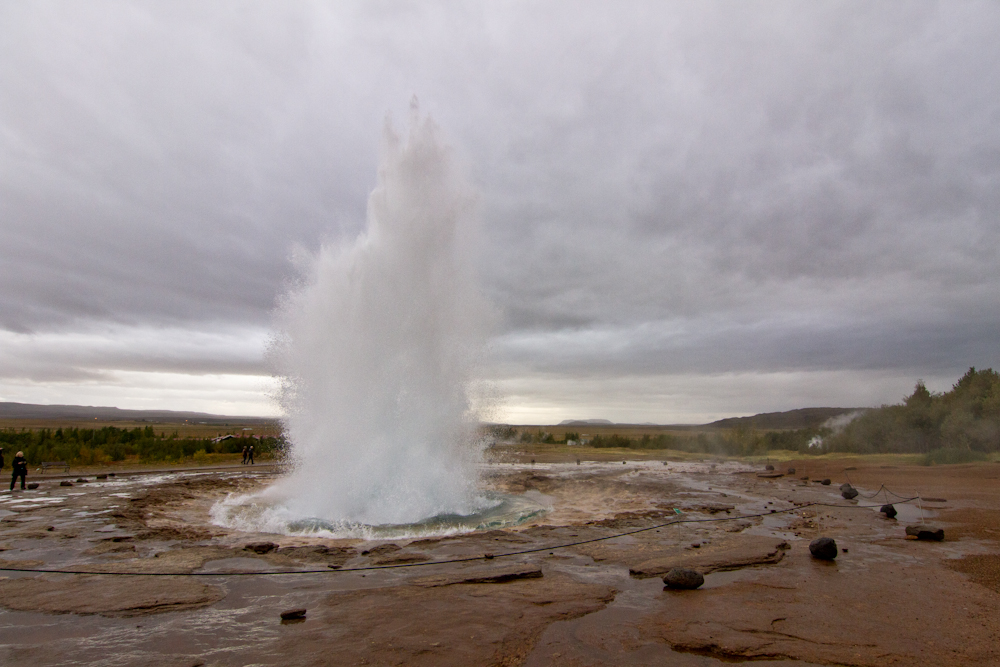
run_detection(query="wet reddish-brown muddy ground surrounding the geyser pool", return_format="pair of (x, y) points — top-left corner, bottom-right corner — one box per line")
(0, 461), (1000, 667)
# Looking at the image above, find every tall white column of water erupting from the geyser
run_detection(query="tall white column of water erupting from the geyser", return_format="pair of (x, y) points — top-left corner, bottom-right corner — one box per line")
(269, 109), (490, 525)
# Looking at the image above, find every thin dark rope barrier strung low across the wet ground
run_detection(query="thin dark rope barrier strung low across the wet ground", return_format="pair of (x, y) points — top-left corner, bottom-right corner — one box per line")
(0, 496), (920, 577)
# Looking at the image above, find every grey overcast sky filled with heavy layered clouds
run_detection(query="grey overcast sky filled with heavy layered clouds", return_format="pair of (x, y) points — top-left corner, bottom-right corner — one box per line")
(0, 0), (1000, 423)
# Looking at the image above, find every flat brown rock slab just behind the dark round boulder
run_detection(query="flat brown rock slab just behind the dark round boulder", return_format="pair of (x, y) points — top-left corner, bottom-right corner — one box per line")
(629, 535), (788, 579)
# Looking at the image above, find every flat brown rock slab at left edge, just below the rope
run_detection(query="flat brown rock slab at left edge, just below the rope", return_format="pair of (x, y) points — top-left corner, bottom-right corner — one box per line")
(0, 576), (226, 616)
